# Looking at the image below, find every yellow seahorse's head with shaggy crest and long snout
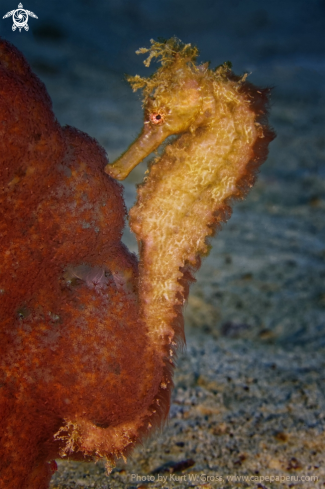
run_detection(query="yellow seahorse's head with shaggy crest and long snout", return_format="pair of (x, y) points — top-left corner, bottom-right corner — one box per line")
(106, 38), (221, 180)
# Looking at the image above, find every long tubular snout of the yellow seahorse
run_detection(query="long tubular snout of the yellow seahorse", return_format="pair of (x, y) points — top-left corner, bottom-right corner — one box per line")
(105, 123), (170, 180)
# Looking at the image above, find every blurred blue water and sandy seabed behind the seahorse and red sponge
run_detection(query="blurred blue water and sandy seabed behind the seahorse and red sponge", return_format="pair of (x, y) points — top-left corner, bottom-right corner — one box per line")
(0, 0), (325, 489)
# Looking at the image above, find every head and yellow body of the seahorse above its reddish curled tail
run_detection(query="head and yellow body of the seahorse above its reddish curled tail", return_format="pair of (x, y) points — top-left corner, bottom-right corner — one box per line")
(106, 38), (275, 384)
